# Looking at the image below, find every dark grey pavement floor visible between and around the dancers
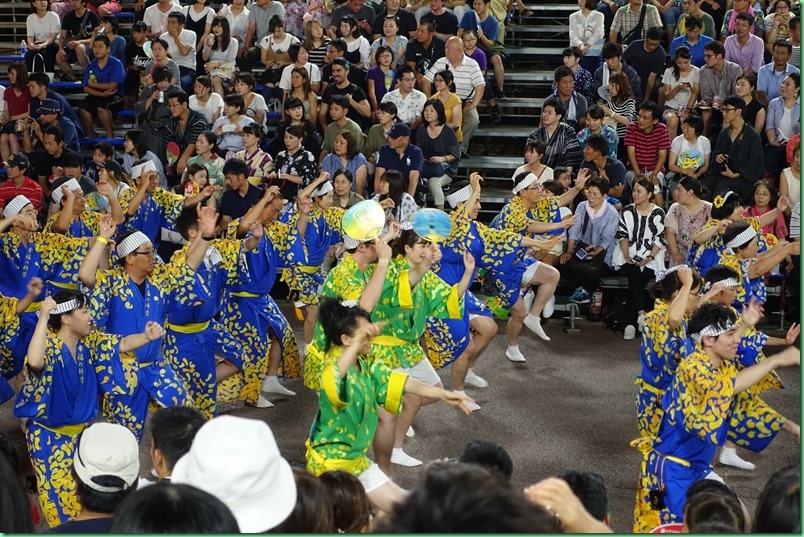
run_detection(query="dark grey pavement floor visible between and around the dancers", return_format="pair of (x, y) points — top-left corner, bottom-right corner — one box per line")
(0, 312), (801, 532)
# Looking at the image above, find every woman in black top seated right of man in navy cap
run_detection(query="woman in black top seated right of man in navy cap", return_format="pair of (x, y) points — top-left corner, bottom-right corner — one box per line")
(416, 99), (461, 210)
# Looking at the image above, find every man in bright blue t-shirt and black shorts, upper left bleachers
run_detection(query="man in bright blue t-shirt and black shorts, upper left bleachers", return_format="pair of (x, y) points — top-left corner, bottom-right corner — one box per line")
(79, 35), (126, 138)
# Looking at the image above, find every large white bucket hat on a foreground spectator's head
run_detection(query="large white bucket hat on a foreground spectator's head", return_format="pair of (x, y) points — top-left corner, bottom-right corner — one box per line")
(172, 414), (296, 533)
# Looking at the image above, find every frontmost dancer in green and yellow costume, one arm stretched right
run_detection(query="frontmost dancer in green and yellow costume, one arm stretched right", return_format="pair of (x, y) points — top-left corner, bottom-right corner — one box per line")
(306, 298), (471, 513)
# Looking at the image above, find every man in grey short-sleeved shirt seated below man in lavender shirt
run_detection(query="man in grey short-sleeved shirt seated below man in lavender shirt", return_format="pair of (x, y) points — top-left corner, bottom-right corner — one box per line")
(697, 41), (743, 135)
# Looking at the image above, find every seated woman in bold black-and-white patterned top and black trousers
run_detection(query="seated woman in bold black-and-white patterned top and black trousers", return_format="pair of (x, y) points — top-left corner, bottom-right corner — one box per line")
(612, 178), (666, 340)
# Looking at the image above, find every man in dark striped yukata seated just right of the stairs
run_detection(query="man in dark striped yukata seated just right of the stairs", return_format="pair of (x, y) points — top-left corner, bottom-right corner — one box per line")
(528, 97), (580, 172)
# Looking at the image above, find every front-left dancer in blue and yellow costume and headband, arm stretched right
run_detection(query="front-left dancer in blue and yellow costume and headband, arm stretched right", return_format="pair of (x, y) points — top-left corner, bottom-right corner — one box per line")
(14, 292), (162, 526)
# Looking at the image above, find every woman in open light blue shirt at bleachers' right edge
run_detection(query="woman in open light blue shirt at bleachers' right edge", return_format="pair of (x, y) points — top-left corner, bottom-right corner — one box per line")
(765, 73), (801, 180)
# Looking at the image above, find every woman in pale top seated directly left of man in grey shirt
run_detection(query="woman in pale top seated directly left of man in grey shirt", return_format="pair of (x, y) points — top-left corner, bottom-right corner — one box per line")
(659, 47), (701, 138)
